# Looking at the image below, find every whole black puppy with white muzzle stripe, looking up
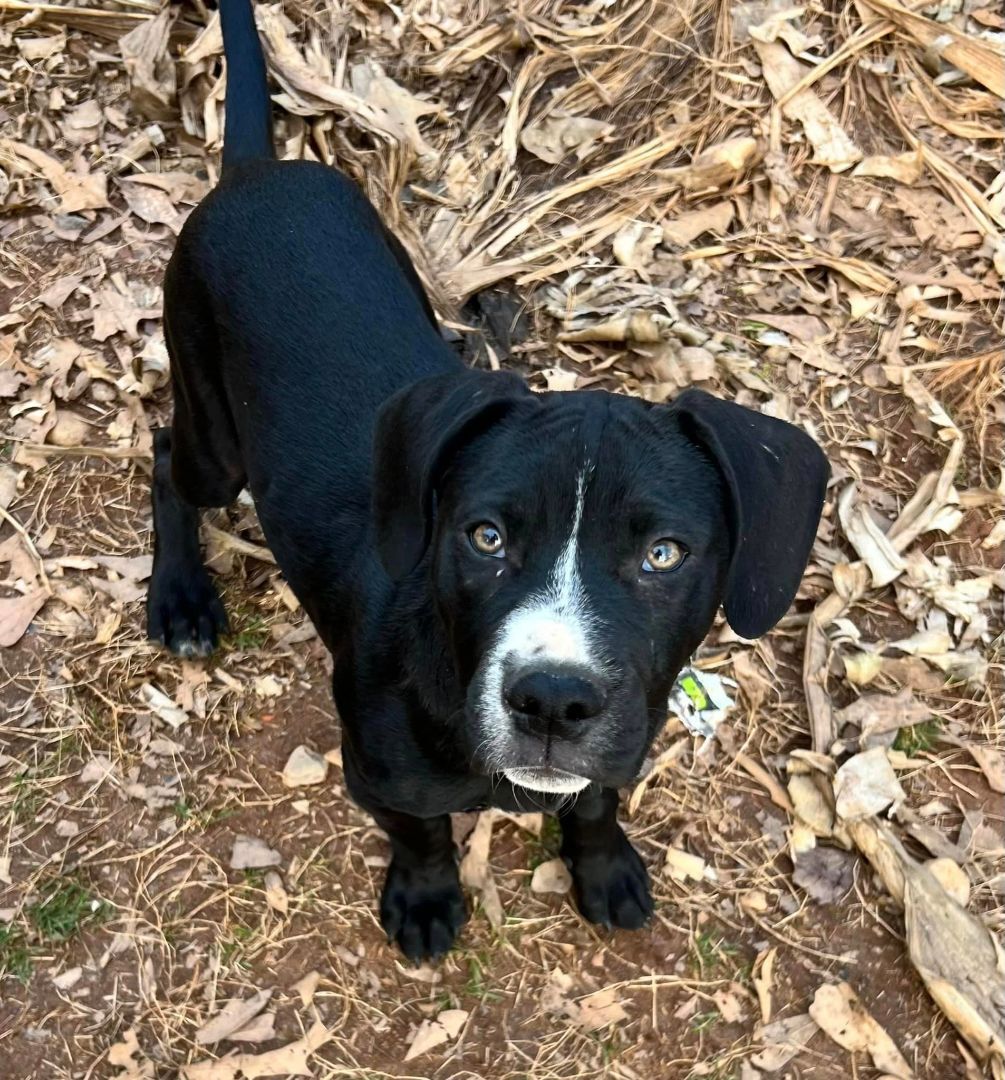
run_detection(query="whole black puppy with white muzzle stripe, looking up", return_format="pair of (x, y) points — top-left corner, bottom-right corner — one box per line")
(148, 0), (828, 958)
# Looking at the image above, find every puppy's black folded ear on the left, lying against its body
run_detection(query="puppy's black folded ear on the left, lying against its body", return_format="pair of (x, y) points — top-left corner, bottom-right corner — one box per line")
(374, 370), (531, 580)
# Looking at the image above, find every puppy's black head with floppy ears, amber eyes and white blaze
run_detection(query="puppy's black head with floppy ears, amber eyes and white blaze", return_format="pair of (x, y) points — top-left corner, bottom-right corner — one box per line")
(375, 372), (828, 793)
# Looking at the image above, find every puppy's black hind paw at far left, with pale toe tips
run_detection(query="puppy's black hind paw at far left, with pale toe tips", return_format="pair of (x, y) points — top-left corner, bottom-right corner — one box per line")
(147, 564), (227, 660)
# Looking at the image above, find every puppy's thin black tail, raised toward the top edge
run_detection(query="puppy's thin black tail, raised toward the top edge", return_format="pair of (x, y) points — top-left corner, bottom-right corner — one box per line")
(219, 0), (275, 170)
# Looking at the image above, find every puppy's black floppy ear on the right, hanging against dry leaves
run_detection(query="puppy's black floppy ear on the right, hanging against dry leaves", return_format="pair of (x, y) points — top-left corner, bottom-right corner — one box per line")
(671, 390), (830, 637)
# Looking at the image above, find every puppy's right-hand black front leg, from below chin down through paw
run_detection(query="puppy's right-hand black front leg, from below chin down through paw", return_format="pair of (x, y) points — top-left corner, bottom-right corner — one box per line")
(558, 785), (653, 930)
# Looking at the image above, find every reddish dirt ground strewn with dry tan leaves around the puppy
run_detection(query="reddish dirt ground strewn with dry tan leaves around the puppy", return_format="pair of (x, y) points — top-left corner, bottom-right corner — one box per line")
(0, 0), (1005, 1080)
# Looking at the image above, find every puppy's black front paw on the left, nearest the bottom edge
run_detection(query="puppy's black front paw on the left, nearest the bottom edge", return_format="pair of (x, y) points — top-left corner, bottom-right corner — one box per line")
(380, 860), (467, 963)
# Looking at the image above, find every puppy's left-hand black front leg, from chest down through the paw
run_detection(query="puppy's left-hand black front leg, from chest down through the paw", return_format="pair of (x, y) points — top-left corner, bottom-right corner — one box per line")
(371, 810), (467, 962)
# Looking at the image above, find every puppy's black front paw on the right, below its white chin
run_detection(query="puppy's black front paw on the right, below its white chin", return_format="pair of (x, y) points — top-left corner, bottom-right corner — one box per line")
(566, 829), (653, 930)
